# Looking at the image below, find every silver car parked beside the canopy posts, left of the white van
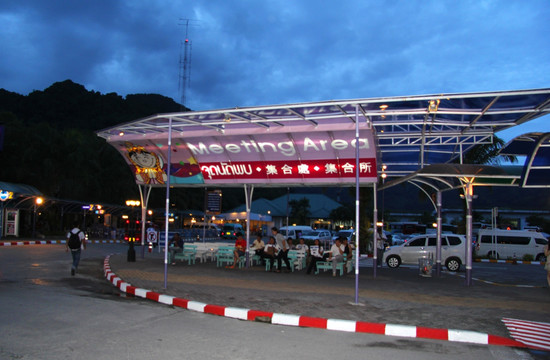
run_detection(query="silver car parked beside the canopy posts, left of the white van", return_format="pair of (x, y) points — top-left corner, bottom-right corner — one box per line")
(383, 234), (466, 271)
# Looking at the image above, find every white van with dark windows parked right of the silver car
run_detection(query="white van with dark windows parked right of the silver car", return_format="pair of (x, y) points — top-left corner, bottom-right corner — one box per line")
(477, 229), (548, 261)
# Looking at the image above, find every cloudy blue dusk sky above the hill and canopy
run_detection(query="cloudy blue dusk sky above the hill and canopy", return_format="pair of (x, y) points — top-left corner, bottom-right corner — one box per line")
(0, 0), (550, 140)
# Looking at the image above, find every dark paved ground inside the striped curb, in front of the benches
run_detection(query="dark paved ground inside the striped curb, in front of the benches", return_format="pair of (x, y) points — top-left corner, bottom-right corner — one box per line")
(109, 247), (550, 337)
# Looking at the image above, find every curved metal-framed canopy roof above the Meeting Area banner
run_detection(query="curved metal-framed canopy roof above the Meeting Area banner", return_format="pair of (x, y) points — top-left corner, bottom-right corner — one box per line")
(97, 88), (550, 181)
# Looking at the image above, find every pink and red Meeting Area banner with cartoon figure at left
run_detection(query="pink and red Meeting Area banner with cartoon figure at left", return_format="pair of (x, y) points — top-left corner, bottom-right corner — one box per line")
(112, 129), (377, 185)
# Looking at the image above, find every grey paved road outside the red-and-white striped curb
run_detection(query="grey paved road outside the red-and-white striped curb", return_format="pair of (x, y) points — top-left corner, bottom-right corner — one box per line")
(0, 245), (550, 359)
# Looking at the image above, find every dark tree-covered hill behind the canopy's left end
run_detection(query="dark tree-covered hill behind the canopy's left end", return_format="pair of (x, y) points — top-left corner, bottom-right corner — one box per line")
(0, 80), (191, 204)
